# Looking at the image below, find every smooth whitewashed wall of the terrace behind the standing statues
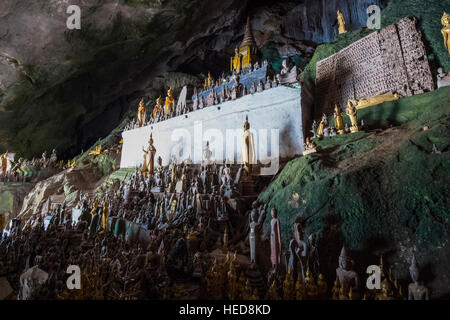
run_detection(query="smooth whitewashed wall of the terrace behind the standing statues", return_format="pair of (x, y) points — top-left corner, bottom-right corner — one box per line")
(120, 86), (304, 168)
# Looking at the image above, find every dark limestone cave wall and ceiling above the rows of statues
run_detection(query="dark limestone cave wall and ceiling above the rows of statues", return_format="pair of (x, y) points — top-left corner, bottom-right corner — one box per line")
(0, 0), (382, 158)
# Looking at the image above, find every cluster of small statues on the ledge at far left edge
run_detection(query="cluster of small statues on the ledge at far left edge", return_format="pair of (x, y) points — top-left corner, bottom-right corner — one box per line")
(0, 149), (61, 182)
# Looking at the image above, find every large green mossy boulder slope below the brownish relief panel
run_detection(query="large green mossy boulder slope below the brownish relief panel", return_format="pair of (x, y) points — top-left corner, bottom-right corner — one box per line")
(259, 88), (450, 297)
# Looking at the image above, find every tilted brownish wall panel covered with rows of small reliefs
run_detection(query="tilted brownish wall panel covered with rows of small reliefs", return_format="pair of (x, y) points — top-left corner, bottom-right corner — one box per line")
(315, 18), (434, 118)
